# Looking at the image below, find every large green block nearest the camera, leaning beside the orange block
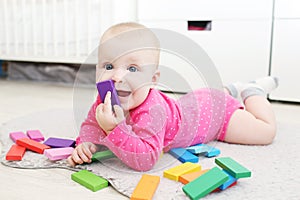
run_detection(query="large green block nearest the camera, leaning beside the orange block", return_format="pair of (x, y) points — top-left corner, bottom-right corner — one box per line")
(182, 167), (228, 199)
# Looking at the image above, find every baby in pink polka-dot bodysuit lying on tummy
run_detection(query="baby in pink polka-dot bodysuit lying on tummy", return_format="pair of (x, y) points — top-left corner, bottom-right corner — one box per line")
(68, 23), (278, 171)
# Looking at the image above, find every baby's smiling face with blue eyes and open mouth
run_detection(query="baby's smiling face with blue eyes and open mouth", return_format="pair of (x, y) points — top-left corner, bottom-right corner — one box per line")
(96, 49), (160, 111)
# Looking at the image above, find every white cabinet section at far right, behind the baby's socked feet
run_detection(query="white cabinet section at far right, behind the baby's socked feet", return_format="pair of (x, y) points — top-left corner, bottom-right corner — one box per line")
(270, 0), (300, 102)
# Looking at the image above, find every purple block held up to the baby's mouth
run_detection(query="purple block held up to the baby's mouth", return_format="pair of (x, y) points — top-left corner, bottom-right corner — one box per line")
(97, 80), (121, 106)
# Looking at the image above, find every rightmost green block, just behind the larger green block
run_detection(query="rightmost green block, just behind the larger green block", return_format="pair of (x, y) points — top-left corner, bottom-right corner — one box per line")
(215, 157), (251, 178)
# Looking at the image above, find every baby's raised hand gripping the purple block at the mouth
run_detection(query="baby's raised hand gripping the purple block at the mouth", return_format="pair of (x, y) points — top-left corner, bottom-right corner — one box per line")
(96, 92), (125, 134)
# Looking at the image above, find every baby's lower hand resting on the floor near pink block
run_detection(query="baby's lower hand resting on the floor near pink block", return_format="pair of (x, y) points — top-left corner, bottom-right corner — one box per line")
(68, 142), (98, 167)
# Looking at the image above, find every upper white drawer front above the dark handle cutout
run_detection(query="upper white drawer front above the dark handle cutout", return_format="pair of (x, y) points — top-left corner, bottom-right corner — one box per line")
(137, 0), (273, 20)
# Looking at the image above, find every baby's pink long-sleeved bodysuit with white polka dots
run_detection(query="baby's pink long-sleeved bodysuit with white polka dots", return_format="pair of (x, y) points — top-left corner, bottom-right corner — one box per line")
(77, 89), (242, 171)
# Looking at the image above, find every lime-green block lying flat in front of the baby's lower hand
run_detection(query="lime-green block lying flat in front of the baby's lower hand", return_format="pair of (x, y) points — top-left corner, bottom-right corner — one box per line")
(71, 170), (108, 192)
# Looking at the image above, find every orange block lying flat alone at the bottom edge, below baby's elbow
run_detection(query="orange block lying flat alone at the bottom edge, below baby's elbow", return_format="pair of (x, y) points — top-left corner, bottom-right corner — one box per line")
(130, 174), (160, 200)
